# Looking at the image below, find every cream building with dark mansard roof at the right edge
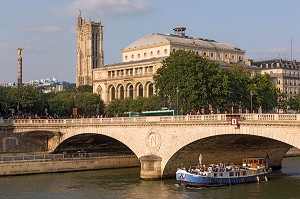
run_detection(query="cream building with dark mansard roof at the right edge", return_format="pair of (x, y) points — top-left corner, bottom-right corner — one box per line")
(252, 59), (300, 98)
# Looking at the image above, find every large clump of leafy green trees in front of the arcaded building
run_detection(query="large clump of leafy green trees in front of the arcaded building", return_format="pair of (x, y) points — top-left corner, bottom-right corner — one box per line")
(154, 50), (277, 112)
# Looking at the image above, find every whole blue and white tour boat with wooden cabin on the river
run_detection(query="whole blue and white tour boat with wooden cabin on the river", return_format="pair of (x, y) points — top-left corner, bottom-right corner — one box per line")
(176, 154), (272, 187)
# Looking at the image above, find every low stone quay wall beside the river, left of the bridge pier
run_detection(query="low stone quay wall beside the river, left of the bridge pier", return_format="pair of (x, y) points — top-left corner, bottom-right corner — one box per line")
(0, 155), (141, 176)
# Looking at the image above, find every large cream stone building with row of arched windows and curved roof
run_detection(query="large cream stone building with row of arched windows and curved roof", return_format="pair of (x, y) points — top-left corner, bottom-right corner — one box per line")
(93, 27), (245, 103)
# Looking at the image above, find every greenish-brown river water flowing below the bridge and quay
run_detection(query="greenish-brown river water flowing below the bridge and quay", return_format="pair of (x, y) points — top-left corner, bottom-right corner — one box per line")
(0, 157), (300, 199)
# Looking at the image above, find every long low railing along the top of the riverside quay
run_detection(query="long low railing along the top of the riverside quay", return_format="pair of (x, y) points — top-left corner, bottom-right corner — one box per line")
(0, 151), (134, 164)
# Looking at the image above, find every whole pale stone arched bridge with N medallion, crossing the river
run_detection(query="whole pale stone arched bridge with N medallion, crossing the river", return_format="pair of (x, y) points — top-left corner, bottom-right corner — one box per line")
(0, 114), (300, 178)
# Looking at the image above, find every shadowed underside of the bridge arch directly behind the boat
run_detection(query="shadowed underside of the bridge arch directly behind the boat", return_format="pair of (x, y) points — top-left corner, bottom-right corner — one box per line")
(162, 134), (291, 177)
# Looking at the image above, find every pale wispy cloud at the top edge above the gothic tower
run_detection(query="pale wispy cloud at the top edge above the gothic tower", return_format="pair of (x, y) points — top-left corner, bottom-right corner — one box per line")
(52, 0), (154, 17)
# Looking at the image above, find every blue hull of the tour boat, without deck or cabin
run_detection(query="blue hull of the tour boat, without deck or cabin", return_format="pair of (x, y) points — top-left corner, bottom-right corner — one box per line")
(176, 169), (271, 187)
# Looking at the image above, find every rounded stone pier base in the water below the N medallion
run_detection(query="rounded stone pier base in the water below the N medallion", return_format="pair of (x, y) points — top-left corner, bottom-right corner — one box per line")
(139, 155), (162, 180)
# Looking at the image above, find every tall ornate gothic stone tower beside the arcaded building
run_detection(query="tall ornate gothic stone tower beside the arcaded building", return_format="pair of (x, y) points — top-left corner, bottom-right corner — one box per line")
(76, 11), (104, 87)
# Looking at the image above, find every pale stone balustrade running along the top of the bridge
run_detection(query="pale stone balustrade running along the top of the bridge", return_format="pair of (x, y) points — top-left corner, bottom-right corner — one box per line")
(0, 114), (300, 125)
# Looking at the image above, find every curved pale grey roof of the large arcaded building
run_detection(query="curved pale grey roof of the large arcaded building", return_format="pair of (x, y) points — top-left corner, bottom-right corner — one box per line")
(124, 33), (242, 51)
